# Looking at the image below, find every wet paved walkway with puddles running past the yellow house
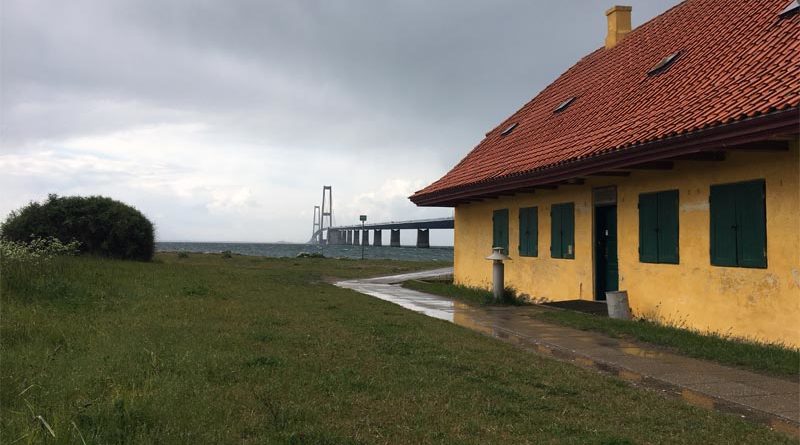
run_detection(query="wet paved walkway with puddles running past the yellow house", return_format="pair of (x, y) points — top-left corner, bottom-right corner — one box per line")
(336, 268), (800, 435)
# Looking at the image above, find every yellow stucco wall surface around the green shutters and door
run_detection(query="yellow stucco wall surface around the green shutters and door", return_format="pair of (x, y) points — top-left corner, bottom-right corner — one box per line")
(454, 141), (800, 346)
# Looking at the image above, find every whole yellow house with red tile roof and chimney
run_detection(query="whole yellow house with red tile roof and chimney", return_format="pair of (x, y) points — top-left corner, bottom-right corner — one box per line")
(411, 0), (800, 346)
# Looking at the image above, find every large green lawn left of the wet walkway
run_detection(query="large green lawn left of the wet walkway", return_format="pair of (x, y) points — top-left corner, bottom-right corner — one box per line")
(0, 251), (793, 444)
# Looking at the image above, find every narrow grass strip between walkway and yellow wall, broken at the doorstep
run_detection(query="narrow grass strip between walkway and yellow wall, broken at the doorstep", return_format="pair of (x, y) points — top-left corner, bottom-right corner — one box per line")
(403, 281), (800, 377)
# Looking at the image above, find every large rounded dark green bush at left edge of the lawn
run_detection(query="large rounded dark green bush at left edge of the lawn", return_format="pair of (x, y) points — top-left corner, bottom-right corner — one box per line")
(0, 195), (155, 261)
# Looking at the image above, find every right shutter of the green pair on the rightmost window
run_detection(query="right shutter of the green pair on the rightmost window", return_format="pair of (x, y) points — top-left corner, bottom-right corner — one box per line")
(735, 181), (767, 267)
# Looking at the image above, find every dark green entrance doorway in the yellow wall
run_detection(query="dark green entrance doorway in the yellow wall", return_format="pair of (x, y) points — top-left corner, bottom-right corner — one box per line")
(594, 190), (619, 301)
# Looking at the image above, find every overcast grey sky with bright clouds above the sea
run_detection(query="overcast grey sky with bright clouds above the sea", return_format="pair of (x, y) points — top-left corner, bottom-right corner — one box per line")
(0, 0), (677, 244)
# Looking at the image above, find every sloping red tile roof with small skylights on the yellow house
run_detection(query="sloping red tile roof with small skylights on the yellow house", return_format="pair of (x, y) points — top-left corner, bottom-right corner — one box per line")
(411, 0), (800, 205)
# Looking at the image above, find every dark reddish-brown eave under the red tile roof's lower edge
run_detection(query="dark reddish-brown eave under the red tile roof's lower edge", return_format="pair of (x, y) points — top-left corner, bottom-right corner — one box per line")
(409, 107), (800, 207)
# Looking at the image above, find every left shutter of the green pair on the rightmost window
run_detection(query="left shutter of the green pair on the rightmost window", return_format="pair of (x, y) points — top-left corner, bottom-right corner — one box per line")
(709, 185), (737, 266)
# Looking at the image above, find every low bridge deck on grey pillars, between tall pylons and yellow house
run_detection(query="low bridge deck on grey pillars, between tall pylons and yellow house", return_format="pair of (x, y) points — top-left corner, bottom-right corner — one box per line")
(309, 217), (455, 248)
